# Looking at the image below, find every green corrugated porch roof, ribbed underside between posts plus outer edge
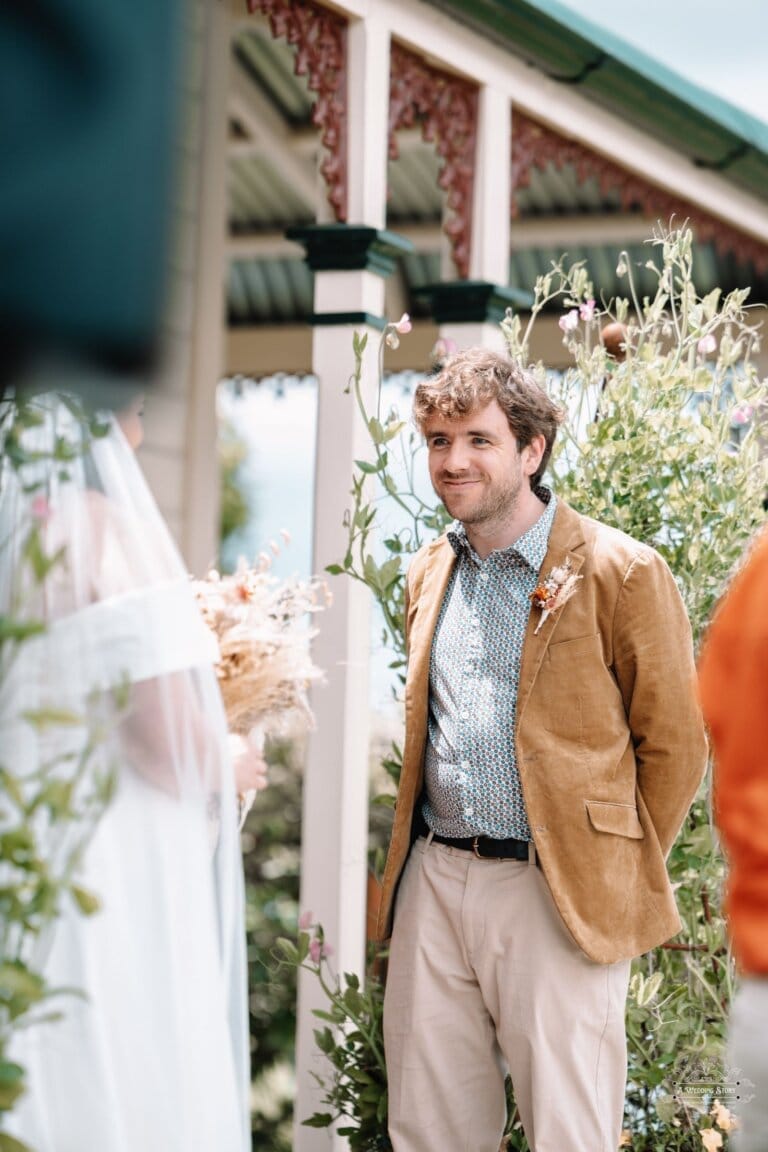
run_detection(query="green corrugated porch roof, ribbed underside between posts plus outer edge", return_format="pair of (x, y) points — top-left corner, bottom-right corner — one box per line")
(228, 12), (768, 326)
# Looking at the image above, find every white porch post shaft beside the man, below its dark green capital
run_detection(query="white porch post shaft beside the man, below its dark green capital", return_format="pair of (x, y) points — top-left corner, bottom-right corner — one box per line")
(294, 301), (383, 1152)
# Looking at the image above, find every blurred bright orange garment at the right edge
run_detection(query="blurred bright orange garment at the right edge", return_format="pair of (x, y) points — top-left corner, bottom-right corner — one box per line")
(699, 531), (768, 973)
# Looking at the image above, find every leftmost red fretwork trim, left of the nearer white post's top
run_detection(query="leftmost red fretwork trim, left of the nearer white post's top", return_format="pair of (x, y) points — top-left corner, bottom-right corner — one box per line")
(248, 0), (347, 221)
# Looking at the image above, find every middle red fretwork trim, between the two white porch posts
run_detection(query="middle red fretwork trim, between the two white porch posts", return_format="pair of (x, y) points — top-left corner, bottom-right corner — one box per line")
(389, 41), (478, 279)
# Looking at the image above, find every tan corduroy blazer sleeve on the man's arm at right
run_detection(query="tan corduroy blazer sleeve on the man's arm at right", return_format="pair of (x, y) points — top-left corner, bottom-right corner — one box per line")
(614, 548), (707, 856)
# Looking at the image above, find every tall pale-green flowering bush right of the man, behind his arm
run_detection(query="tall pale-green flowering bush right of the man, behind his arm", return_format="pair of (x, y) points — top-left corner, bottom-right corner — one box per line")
(502, 232), (768, 1152)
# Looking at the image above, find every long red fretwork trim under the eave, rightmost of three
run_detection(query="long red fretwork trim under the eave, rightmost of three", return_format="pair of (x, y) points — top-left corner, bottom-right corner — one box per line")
(511, 112), (768, 273)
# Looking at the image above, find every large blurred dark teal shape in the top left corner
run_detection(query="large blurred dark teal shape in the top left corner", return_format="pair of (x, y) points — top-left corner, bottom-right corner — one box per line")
(0, 0), (184, 374)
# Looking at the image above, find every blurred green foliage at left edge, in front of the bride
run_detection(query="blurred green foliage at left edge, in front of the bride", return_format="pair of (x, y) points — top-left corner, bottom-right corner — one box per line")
(0, 396), (120, 1152)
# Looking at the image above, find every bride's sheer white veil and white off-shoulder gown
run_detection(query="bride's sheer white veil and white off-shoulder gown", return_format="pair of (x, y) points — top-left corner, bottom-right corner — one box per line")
(0, 396), (250, 1152)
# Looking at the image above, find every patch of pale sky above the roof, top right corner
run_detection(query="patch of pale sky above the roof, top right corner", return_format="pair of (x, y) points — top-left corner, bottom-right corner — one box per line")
(561, 0), (768, 122)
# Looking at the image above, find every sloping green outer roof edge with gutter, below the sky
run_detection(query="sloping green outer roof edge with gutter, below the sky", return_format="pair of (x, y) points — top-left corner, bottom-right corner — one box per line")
(429, 0), (768, 196)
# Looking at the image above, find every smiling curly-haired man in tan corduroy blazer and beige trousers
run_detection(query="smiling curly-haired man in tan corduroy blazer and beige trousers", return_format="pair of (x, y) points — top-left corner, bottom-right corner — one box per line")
(379, 349), (706, 1152)
